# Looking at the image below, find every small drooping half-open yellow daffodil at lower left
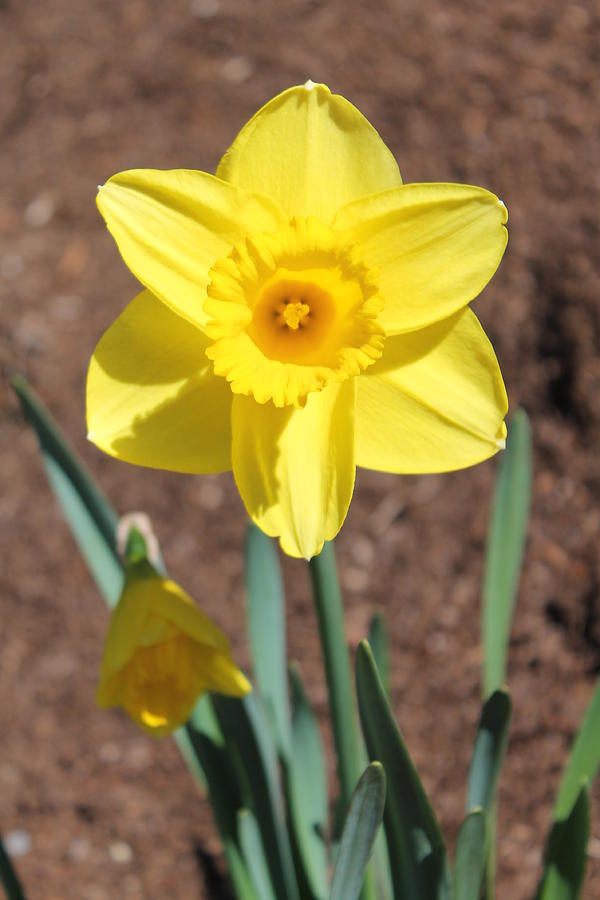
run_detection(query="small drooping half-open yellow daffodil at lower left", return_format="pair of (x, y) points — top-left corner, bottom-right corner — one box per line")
(97, 563), (251, 737)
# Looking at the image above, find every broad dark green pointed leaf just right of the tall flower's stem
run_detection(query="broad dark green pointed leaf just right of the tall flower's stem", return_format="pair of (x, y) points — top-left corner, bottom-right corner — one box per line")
(356, 641), (452, 900)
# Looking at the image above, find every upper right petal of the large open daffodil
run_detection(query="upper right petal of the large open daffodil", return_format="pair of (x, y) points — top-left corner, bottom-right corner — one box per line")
(333, 184), (507, 334)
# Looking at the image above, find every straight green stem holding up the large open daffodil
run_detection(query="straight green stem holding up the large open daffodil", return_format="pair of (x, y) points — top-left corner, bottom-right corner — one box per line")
(308, 543), (361, 816)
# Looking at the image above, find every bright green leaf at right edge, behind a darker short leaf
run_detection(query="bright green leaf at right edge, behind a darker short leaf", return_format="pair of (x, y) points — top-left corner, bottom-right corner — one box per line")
(554, 679), (600, 819)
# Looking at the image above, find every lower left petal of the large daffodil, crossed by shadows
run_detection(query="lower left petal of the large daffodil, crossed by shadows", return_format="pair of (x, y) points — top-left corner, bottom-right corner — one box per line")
(87, 291), (231, 472)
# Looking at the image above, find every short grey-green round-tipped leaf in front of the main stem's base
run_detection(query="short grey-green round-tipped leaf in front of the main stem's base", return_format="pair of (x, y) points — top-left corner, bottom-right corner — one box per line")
(329, 762), (385, 900)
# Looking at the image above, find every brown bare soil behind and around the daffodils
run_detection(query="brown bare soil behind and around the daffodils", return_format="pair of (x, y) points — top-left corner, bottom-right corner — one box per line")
(0, 0), (600, 900)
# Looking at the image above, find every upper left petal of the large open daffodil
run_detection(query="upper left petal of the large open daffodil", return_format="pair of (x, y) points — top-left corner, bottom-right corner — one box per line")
(97, 169), (284, 326)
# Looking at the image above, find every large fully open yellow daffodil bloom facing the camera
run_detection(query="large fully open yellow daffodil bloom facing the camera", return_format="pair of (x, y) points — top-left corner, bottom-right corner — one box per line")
(87, 82), (507, 558)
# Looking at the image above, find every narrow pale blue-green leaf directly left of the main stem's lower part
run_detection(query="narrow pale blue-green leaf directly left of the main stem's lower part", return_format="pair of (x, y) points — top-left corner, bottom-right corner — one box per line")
(284, 666), (329, 900)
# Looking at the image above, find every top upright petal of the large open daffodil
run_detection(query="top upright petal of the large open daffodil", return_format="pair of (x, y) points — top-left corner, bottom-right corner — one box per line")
(217, 81), (402, 225)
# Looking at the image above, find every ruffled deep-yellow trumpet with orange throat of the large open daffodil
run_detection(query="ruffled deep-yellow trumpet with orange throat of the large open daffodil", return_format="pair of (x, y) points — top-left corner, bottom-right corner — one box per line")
(204, 219), (384, 406)
